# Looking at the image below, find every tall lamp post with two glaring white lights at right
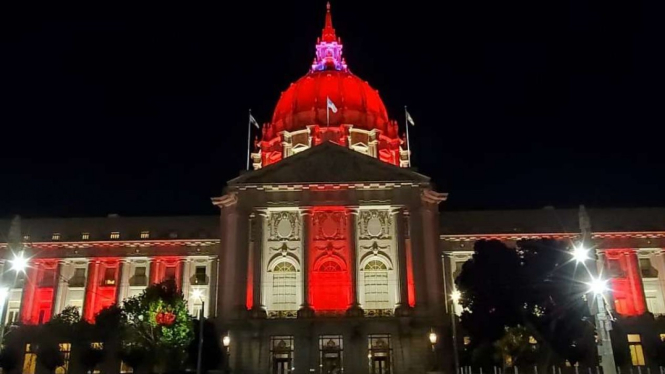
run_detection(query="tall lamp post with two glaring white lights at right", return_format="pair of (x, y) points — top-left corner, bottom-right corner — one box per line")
(571, 244), (616, 374)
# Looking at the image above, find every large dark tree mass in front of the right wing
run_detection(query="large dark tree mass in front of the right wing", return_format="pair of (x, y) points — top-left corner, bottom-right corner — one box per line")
(455, 240), (594, 363)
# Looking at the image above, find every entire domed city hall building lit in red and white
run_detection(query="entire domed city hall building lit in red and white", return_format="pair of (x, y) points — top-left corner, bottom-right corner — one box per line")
(0, 6), (665, 374)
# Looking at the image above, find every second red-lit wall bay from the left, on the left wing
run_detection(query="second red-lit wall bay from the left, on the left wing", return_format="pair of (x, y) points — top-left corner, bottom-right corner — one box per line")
(83, 258), (120, 322)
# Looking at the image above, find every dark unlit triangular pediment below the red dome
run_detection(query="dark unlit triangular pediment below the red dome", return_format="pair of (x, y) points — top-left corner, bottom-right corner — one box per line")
(228, 142), (430, 185)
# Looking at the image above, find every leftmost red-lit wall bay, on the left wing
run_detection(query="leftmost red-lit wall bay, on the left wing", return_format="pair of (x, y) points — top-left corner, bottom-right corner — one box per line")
(21, 259), (58, 324)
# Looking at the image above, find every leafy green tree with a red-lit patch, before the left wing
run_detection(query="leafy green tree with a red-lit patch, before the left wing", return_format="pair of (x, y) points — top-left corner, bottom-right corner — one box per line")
(121, 280), (194, 373)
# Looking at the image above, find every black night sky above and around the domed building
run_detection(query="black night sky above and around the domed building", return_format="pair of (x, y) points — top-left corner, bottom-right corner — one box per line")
(0, 0), (665, 217)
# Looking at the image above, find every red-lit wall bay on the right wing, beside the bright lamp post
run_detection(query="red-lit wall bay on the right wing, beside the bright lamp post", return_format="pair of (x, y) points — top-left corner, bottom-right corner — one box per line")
(605, 249), (646, 316)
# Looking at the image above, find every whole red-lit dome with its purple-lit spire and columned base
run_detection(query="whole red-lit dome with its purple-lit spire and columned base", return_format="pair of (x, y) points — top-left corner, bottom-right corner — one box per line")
(250, 3), (408, 168)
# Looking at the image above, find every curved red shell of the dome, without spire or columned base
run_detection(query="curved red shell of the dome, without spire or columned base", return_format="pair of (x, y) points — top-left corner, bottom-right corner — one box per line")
(272, 70), (389, 132)
